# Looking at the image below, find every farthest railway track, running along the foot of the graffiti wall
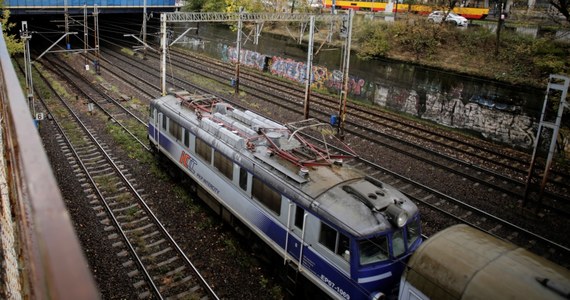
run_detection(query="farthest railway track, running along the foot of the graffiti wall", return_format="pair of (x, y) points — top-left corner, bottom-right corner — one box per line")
(161, 47), (568, 189)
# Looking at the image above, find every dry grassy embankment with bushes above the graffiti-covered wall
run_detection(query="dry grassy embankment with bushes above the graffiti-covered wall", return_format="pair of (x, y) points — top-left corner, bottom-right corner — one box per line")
(264, 13), (570, 89)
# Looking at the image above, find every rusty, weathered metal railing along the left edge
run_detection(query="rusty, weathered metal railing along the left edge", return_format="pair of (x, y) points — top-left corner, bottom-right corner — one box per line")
(0, 26), (100, 299)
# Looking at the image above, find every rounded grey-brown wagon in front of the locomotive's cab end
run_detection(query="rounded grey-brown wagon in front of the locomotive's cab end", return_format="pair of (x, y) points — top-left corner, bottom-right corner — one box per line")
(399, 224), (570, 300)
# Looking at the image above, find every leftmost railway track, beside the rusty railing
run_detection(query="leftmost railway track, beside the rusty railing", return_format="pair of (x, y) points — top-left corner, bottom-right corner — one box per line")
(21, 59), (218, 299)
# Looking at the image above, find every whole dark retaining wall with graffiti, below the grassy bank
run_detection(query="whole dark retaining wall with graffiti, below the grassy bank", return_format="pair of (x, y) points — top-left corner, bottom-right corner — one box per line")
(174, 23), (544, 149)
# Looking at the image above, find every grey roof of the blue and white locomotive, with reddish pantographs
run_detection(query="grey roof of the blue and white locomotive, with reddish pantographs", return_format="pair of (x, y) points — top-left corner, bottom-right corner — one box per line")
(155, 92), (417, 236)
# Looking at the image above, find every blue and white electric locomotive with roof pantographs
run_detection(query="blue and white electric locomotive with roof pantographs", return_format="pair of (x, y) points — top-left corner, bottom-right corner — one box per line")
(148, 92), (422, 299)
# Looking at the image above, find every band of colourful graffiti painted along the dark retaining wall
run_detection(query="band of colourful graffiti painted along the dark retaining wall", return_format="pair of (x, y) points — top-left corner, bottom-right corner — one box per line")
(210, 40), (536, 147)
